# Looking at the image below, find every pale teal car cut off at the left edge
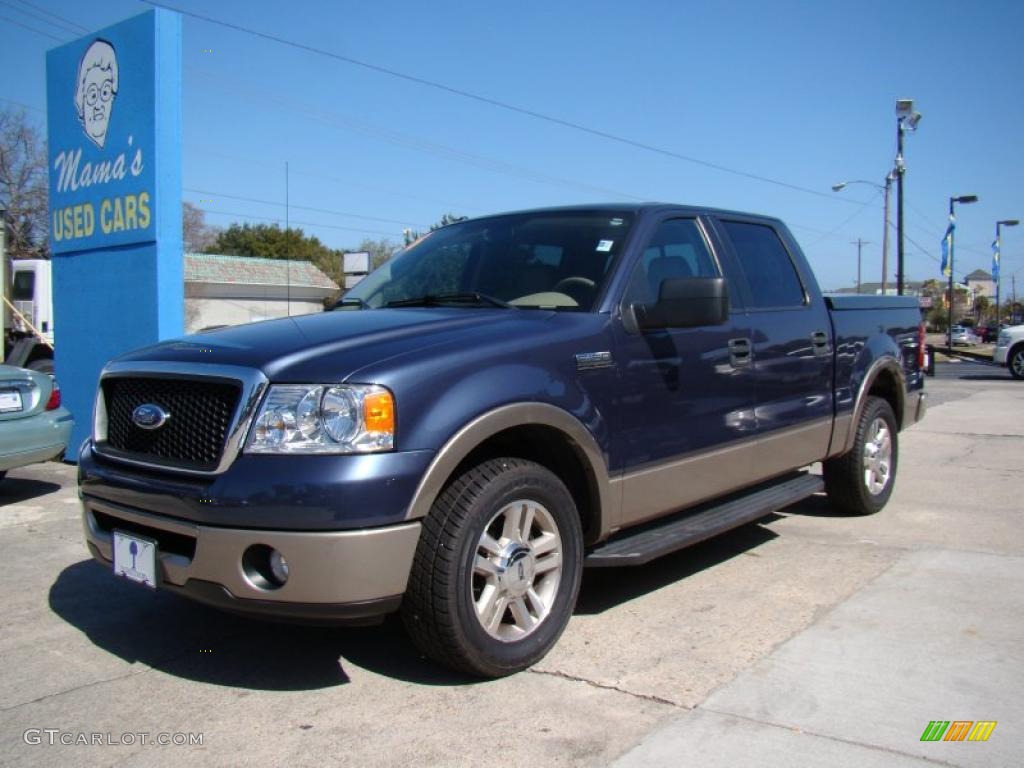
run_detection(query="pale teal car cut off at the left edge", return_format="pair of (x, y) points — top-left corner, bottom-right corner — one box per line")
(0, 366), (74, 480)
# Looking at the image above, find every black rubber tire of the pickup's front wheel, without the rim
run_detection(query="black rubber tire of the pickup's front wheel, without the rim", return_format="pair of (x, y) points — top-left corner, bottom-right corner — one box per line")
(401, 458), (583, 678)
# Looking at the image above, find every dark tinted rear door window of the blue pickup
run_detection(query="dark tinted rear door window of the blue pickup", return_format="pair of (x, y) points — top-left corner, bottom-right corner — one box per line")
(722, 221), (807, 309)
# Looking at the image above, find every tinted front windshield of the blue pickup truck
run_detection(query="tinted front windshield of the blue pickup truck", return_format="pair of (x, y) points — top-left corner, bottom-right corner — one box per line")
(336, 211), (633, 311)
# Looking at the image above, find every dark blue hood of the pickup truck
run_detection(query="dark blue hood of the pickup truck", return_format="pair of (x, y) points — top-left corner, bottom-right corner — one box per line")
(117, 307), (554, 382)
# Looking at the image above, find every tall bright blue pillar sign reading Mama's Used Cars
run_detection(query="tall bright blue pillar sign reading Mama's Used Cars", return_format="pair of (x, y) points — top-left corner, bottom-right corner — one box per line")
(46, 8), (184, 459)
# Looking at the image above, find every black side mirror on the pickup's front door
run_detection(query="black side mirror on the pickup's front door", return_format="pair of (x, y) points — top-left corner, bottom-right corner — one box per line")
(633, 278), (729, 331)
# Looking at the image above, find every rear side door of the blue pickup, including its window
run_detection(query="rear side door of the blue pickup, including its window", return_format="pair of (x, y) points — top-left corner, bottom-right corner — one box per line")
(716, 216), (834, 472)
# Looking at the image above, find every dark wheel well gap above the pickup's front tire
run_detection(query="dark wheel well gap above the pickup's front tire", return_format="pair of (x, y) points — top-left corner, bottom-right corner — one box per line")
(452, 425), (601, 544)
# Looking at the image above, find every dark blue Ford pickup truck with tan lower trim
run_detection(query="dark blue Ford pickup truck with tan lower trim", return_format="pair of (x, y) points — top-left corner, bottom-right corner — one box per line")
(79, 204), (925, 677)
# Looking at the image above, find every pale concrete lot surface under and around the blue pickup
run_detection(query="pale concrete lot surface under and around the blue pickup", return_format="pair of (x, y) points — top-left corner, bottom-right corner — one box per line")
(0, 370), (1024, 768)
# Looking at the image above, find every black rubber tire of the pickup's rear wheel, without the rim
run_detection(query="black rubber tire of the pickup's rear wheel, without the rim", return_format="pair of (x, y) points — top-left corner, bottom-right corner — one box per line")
(824, 397), (899, 515)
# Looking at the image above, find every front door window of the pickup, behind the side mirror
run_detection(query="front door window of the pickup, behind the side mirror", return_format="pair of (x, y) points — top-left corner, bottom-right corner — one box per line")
(626, 219), (720, 304)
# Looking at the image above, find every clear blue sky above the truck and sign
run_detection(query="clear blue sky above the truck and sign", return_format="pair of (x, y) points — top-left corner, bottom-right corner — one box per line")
(0, 0), (1024, 295)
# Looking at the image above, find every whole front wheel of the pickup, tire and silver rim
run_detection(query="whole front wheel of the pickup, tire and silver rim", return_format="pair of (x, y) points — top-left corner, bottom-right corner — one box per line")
(402, 458), (583, 677)
